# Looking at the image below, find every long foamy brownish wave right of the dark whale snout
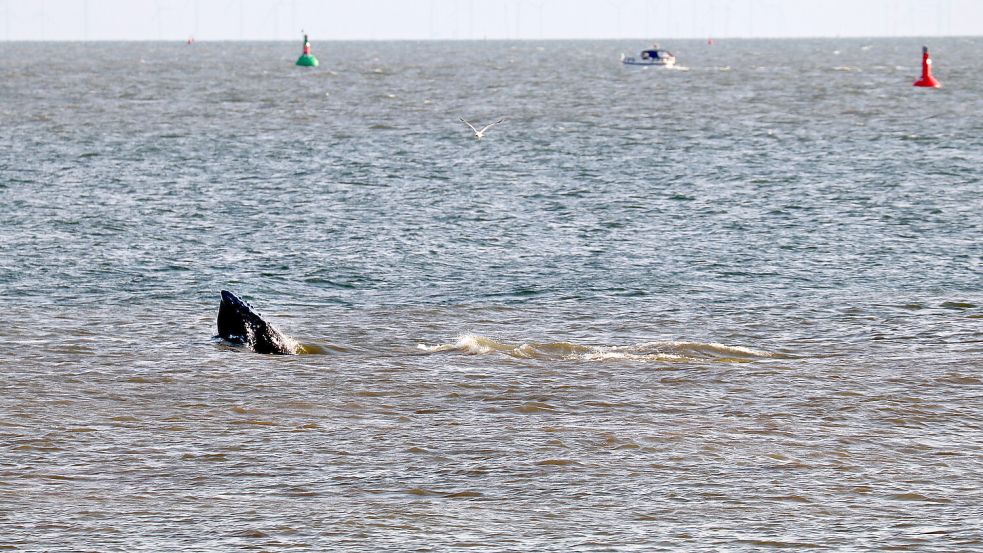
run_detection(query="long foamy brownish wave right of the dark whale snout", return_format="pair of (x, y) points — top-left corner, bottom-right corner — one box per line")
(417, 333), (780, 363)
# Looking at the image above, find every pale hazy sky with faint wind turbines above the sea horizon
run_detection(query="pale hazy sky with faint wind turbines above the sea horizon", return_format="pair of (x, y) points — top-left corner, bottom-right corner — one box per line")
(0, 0), (983, 41)
